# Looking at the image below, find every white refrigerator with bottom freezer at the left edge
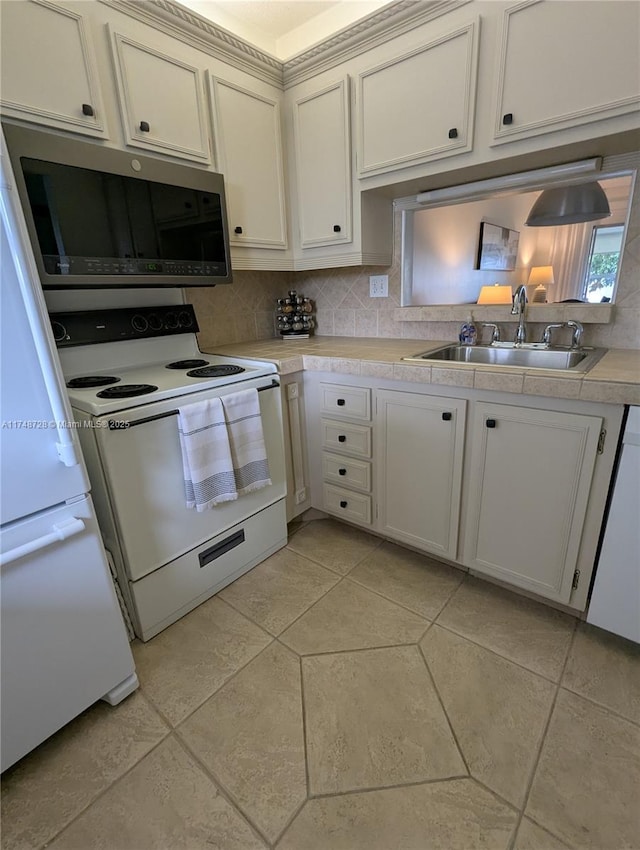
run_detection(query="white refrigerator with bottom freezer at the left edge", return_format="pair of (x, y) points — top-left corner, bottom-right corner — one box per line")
(0, 131), (138, 770)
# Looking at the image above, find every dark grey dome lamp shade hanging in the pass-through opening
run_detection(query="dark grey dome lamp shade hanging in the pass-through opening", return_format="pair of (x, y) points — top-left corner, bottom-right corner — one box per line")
(525, 182), (611, 227)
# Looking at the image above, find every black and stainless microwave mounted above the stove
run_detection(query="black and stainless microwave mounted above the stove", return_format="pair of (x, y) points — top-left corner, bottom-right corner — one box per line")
(3, 123), (232, 289)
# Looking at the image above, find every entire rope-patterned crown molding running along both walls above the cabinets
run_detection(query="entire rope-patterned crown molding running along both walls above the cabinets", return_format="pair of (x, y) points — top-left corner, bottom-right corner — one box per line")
(98, 0), (472, 88)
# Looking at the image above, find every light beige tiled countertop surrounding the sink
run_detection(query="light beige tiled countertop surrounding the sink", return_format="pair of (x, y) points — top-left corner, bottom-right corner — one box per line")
(210, 336), (640, 404)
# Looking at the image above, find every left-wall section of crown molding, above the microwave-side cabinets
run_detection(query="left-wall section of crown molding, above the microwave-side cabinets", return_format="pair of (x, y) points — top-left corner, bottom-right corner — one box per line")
(98, 0), (283, 88)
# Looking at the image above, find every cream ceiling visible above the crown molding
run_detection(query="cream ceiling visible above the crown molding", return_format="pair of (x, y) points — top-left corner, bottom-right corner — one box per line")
(174, 0), (390, 61)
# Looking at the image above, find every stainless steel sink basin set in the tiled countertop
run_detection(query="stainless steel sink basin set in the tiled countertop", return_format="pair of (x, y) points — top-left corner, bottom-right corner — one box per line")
(403, 343), (606, 372)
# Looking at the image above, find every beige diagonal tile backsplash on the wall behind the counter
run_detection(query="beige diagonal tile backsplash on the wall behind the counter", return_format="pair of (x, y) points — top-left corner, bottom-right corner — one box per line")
(187, 172), (640, 351)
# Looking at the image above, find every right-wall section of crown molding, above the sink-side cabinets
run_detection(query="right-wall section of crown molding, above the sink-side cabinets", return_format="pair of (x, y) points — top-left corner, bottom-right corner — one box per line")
(283, 0), (472, 88)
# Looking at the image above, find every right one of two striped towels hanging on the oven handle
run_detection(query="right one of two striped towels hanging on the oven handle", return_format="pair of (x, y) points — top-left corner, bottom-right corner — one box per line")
(221, 389), (271, 496)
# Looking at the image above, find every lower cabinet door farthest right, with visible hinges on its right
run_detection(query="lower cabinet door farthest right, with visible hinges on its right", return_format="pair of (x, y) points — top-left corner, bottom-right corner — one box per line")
(465, 402), (602, 603)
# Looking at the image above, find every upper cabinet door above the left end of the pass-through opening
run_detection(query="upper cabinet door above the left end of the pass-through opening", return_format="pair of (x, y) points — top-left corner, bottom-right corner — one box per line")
(358, 23), (478, 177)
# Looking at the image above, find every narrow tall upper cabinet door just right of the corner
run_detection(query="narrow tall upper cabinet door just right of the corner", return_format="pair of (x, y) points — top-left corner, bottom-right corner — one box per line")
(293, 77), (352, 248)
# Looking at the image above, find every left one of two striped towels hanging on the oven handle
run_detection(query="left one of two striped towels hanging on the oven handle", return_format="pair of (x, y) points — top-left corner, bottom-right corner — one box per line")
(178, 398), (238, 512)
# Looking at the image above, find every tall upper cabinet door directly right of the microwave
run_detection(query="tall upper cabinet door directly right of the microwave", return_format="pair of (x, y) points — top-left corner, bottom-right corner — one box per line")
(211, 77), (287, 248)
